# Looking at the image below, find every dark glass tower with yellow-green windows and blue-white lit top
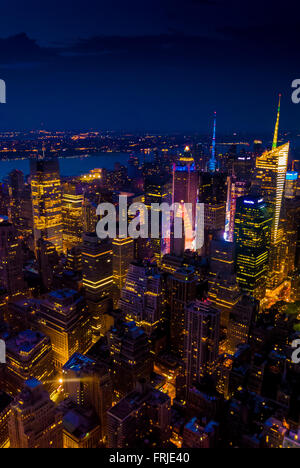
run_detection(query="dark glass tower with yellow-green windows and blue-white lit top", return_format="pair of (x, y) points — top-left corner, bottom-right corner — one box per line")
(234, 197), (272, 299)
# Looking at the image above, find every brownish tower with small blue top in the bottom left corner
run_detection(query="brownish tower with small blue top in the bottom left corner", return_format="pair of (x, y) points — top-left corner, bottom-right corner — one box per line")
(8, 379), (63, 448)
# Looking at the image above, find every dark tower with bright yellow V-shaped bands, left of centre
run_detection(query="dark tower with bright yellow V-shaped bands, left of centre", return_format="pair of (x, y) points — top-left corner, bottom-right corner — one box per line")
(81, 232), (114, 342)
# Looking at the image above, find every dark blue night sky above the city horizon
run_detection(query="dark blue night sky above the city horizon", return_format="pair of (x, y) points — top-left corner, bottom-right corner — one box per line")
(0, 0), (300, 134)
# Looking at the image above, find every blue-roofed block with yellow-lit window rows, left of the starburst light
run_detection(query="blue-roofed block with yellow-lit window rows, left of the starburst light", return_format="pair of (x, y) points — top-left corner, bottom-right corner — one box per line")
(6, 330), (54, 394)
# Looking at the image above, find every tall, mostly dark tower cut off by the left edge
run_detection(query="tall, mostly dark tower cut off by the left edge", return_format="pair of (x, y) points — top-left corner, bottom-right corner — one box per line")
(0, 216), (25, 296)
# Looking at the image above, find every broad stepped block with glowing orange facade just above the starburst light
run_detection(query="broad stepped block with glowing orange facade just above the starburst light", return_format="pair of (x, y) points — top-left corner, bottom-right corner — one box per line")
(38, 289), (91, 370)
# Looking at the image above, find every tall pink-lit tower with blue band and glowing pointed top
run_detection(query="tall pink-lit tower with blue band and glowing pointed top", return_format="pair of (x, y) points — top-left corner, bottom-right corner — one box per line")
(172, 146), (199, 255)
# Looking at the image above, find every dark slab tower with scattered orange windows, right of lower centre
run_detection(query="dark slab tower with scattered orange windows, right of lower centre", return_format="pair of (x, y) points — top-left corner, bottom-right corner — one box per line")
(184, 300), (220, 389)
